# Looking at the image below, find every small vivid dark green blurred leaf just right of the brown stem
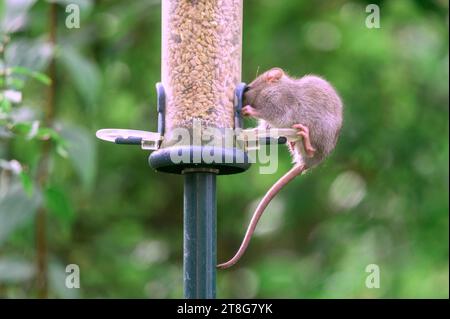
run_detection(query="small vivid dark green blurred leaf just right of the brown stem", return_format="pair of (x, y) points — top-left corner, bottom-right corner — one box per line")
(44, 186), (74, 222)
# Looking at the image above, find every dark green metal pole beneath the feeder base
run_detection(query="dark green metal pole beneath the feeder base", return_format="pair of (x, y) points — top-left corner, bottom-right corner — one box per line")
(183, 170), (216, 299)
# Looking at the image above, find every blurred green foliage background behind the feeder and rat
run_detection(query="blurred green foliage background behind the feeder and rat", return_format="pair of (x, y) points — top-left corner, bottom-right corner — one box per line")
(0, 0), (449, 298)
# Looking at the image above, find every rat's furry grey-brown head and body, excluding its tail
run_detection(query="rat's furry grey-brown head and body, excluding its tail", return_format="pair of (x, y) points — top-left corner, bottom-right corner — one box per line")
(244, 68), (343, 168)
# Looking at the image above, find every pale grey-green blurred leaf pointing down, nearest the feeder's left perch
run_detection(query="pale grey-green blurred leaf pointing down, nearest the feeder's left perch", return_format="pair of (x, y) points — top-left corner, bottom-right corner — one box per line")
(61, 124), (97, 190)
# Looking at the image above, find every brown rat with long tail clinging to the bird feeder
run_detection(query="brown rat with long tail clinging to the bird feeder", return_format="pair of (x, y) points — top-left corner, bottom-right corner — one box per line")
(217, 68), (343, 269)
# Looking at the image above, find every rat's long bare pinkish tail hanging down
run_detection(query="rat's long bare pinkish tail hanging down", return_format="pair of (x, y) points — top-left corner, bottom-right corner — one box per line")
(217, 164), (305, 269)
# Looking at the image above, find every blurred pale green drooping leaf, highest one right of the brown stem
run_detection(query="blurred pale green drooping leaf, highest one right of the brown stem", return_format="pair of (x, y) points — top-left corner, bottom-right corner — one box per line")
(58, 47), (100, 106)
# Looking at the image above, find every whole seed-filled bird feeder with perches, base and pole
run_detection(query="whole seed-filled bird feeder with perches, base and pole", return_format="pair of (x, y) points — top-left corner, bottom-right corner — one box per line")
(97, 0), (295, 298)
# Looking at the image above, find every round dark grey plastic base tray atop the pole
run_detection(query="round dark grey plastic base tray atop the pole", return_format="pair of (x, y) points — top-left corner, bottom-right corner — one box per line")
(148, 145), (251, 175)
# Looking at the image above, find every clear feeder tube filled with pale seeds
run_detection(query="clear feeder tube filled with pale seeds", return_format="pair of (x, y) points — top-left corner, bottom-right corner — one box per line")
(161, 0), (243, 141)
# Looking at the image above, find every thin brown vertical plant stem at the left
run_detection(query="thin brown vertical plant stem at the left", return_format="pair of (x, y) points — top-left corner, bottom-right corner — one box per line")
(36, 3), (57, 298)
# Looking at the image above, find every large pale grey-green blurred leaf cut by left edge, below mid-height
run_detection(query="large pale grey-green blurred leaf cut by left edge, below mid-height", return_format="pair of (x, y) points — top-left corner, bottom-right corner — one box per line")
(0, 184), (41, 244)
